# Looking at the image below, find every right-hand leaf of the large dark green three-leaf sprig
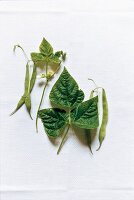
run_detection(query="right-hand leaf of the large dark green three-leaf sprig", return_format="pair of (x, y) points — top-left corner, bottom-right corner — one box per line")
(71, 96), (99, 129)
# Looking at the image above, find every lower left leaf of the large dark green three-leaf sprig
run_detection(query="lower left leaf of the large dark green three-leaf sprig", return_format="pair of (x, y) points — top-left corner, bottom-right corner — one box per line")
(38, 108), (68, 137)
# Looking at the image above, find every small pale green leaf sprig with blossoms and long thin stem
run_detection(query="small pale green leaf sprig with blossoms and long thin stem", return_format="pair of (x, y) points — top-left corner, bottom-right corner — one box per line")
(31, 38), (66, 132)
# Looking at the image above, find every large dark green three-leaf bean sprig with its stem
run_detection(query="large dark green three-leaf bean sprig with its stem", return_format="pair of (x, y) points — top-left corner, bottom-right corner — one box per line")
(38, 68), (108, 153)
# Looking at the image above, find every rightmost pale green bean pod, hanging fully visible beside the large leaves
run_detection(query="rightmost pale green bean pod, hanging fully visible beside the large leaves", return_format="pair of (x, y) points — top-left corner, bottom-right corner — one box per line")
(97, 88), (108, 151)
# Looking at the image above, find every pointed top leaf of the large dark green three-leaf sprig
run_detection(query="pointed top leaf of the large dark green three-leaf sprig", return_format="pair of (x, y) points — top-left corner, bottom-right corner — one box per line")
(49, 68), (84, 109)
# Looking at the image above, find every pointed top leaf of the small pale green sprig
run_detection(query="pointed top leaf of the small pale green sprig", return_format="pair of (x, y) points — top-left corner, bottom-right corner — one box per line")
(39, 38), (53, 56)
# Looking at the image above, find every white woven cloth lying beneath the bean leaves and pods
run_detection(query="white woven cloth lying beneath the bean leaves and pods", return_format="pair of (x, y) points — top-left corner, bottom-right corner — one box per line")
(0, 0), (134, 200)
